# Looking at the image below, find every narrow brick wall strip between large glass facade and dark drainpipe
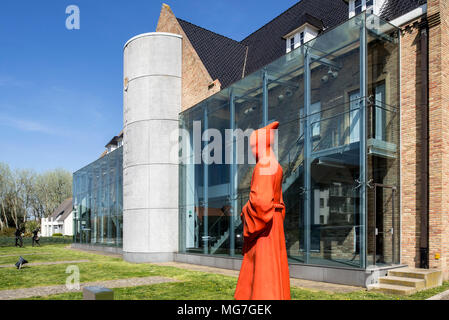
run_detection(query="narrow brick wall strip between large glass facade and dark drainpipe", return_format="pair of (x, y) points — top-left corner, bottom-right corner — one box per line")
(401, 23), (425, 267)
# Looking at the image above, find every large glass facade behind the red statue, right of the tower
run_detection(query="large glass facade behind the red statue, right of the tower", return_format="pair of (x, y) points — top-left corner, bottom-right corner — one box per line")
(179, 13), (400, 268)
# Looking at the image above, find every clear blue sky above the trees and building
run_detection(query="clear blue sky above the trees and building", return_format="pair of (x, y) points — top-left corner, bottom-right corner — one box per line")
(0, 0), (298, 172)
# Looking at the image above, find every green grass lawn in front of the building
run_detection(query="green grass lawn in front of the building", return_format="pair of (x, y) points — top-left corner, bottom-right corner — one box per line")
(0, 245), (449, 300)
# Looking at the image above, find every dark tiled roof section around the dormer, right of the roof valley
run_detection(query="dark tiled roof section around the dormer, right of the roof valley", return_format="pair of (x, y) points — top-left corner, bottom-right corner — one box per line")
(242, 0), (349, 74)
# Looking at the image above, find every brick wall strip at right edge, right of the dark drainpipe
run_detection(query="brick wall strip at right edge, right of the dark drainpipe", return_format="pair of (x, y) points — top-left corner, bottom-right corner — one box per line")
(427, 0), (449, 279)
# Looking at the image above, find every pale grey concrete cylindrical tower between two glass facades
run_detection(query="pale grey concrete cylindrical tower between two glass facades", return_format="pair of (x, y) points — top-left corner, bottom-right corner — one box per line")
(123, 32), (182, 262)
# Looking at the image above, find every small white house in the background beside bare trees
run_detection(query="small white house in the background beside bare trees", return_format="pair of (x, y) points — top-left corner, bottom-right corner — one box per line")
(41, 198), (73, 237)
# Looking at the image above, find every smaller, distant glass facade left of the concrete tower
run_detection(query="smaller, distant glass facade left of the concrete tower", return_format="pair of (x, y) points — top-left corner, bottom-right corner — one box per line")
(73, 147), (123, 247)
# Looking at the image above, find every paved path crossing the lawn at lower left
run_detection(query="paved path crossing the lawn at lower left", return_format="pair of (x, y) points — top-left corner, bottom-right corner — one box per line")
(0, 277), (177, 300)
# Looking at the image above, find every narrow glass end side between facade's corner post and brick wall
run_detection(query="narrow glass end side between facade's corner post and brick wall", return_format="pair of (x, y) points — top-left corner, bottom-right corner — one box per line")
(367, 15), (400, 265)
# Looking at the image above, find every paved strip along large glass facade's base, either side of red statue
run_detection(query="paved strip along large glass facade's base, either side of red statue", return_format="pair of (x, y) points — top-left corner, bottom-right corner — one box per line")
(155, 262), (364, 293)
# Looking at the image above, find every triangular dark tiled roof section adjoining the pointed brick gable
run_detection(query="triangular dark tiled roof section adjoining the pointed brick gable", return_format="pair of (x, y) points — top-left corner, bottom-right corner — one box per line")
(177, 18), (246, 88)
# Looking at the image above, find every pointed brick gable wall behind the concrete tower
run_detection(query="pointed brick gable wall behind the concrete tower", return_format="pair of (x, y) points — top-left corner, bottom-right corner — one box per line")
(156, 4), (221, 111)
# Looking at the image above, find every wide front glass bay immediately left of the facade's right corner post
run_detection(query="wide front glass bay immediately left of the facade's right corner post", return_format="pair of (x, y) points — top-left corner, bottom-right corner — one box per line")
(306, 26), (363, 267)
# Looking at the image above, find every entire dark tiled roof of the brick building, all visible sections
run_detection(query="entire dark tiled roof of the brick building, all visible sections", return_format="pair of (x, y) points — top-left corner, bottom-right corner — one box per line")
(174, 0), (427, 89)
